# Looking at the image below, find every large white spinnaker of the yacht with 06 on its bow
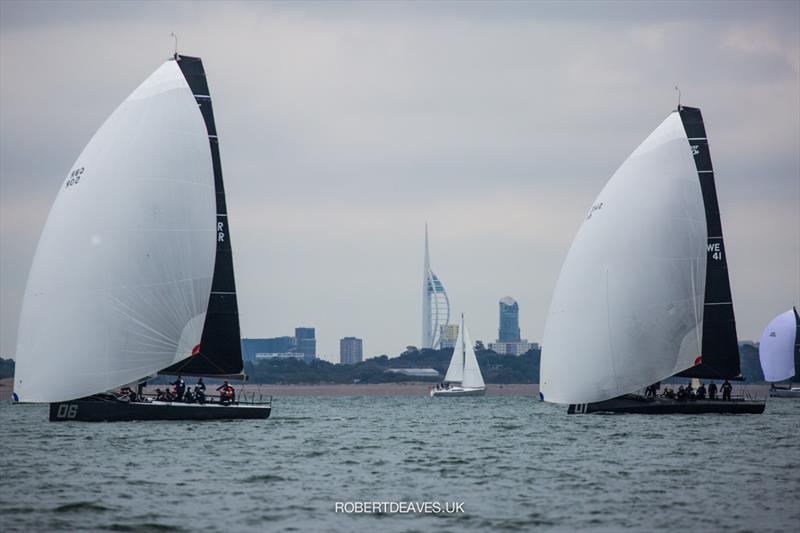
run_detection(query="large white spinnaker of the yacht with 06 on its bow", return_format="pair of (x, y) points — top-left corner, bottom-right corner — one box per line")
(14, 61), (216, 402)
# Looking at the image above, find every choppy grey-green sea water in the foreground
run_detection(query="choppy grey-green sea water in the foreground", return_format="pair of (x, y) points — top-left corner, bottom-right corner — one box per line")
(0, 396), (800, 533)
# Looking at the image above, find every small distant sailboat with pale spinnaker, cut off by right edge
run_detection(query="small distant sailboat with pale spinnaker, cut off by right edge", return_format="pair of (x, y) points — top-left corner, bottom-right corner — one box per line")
(758, 308), (800, 398)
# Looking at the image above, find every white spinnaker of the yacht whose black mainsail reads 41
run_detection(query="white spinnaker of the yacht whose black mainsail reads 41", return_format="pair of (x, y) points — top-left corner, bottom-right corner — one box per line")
(541, 112), (708, 403)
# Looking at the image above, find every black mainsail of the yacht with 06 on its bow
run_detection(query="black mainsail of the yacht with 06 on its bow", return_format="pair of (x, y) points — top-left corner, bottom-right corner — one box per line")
(160, 54), (243, 377)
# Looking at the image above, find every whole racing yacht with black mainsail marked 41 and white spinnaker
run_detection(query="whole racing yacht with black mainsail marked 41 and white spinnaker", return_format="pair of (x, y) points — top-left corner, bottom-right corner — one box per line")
(540, 106), (764, 414)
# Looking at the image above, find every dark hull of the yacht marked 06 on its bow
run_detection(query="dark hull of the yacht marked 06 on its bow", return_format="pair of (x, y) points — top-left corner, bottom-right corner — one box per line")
(50, 399), (272, 422)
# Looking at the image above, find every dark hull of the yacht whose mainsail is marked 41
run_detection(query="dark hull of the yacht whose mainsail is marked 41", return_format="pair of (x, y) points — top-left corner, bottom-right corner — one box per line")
(567, 395), (766, 415)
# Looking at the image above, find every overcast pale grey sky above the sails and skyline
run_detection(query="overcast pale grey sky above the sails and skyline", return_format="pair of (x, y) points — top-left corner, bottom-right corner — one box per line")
(0, 0), (800, 360)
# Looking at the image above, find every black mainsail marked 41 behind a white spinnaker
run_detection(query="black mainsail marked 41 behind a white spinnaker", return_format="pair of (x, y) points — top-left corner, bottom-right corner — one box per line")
(678, 107), (741, 379)
